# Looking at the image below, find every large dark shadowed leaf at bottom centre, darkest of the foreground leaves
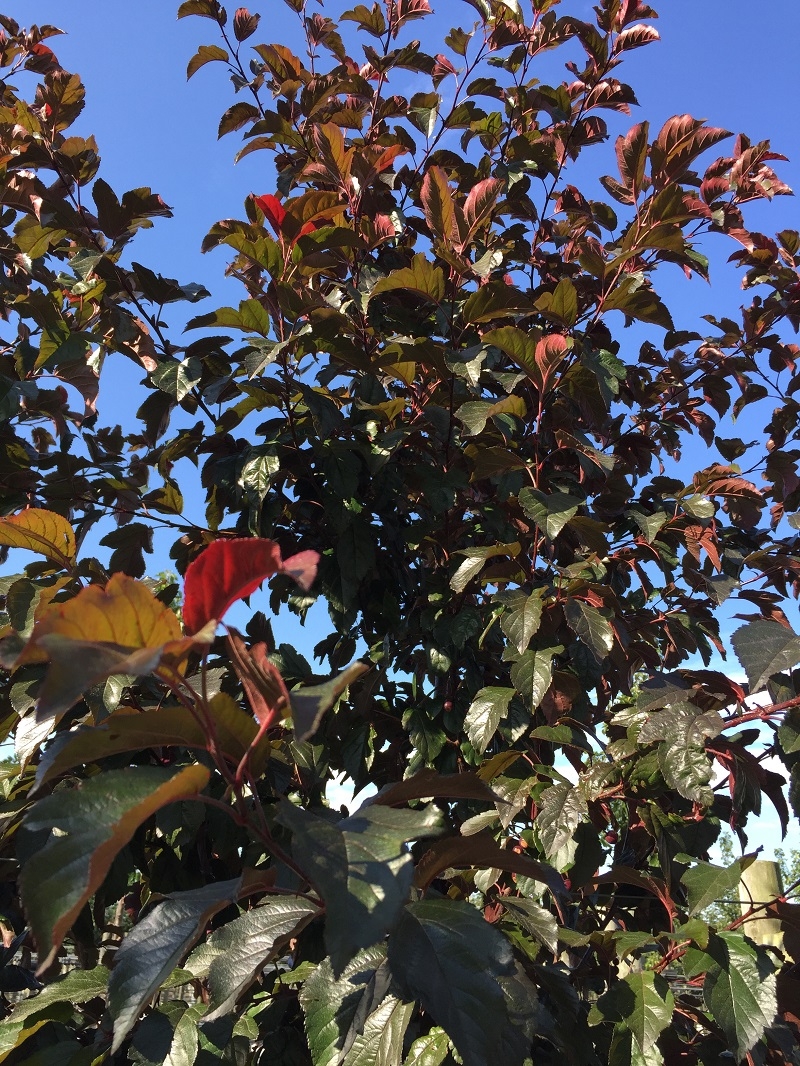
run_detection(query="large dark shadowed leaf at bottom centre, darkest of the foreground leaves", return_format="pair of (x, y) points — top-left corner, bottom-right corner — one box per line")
(388, 900), (528, 1066)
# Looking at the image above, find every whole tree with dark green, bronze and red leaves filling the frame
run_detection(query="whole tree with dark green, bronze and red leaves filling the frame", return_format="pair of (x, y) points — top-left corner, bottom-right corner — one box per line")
(0, 0), (800, 1066)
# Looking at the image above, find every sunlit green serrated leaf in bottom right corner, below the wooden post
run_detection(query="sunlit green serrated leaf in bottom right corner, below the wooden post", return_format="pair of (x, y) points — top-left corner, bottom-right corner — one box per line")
(703, 933), (778, 1062)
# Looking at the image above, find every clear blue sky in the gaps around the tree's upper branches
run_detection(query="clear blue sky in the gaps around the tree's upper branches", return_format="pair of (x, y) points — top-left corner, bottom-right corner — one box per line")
(6, 0), (800, 846)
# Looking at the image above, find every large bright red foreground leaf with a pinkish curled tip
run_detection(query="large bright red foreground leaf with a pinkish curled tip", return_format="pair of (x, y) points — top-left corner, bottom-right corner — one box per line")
(183, 537), (319, 633)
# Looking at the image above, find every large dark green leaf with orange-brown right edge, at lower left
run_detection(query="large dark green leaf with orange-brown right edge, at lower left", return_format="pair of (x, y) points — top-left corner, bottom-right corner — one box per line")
(21, 765), (210, 971)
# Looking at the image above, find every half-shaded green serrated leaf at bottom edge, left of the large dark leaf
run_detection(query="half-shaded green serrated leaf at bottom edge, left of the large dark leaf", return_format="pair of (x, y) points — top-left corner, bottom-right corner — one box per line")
(300, 946), (385, 1066)
